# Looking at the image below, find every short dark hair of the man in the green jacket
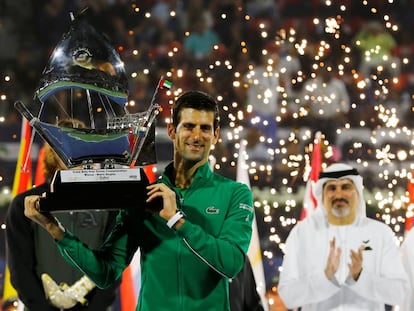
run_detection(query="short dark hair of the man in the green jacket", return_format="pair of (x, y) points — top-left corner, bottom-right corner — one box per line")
(172, 91), (220, 130)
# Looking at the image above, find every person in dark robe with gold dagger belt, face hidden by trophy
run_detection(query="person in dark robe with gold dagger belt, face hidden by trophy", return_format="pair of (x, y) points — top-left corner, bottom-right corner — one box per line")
(6, 119), (119, 311)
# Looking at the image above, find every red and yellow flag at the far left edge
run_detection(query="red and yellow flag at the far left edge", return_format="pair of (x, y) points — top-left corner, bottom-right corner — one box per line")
(2, 118), (32, 301)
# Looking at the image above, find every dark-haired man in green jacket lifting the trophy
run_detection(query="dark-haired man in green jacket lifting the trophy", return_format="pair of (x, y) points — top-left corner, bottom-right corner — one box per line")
(25, 91), (254, 311)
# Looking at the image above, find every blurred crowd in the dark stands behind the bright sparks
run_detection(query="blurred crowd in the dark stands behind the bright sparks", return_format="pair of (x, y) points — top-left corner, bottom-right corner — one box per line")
(0, 0), (414, 189)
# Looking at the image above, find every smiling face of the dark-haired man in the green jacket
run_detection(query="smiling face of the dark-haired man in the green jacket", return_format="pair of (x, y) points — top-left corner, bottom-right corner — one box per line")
(168, 108), (219, 168)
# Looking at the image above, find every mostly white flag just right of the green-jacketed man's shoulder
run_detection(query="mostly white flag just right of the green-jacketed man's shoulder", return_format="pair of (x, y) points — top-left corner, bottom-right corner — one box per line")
(236, 140), (268, 311)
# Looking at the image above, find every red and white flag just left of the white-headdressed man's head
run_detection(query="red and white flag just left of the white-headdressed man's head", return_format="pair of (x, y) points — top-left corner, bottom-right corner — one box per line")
(300, 132), (322, 219)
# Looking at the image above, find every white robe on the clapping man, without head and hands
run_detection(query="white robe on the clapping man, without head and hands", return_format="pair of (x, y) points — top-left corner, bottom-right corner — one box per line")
(278, 212), (409, 311)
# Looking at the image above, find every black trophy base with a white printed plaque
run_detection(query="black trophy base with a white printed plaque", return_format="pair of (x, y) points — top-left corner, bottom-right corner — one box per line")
(40, 168), (148, 212)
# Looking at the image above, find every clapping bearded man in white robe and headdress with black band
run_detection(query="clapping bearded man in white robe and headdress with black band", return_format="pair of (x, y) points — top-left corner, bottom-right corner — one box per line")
(278, 163), (409, 311)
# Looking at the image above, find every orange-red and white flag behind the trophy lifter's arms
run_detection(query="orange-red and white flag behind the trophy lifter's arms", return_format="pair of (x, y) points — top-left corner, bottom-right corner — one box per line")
(120, 164), (156, 311)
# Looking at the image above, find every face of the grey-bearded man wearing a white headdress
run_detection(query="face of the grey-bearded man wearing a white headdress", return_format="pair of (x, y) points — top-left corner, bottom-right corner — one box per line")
(322, 178), (359, 225)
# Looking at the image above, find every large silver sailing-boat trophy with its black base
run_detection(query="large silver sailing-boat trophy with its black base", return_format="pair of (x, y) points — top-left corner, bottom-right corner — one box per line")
(15, 12), (170, 211)
